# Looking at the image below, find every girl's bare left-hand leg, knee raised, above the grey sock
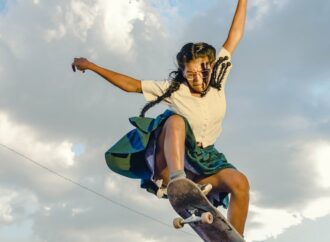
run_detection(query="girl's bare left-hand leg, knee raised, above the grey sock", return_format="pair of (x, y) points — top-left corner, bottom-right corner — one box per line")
(155, 115), (186, 184)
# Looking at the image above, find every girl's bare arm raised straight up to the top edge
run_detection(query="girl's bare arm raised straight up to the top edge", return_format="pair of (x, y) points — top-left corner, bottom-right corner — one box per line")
(223, 0), (247, 54)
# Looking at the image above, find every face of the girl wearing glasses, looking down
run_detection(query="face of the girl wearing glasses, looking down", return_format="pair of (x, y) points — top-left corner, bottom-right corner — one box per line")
(183, 57), (212, 93)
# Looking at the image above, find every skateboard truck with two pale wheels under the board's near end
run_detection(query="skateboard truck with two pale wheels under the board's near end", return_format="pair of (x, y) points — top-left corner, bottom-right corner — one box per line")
(173, 209), (213, 229)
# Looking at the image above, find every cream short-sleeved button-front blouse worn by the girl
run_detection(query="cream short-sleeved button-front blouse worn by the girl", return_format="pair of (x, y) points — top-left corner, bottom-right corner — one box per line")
(141, 47), (232, 147)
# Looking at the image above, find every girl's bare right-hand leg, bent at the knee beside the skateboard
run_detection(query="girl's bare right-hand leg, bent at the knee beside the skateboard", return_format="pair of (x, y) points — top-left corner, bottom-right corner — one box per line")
(195, 168), (250, 235)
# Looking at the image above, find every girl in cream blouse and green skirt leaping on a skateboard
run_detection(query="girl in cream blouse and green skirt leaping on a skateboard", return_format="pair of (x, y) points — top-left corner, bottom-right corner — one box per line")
(72, 0), (249, 235)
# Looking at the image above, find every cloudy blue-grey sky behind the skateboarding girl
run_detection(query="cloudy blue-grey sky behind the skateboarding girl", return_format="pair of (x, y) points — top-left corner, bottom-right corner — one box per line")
(0, 0), (330, 242)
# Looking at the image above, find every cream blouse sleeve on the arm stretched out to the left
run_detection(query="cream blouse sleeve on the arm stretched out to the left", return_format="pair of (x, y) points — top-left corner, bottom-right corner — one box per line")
(141, 80), (171, 104)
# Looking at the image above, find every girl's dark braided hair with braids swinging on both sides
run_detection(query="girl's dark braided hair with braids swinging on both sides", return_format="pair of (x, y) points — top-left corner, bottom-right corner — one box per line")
(140, 42), (231, 117)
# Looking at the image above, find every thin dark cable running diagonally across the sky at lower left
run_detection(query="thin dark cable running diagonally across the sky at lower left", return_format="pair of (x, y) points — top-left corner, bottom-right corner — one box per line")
(0, 143), (196, 237)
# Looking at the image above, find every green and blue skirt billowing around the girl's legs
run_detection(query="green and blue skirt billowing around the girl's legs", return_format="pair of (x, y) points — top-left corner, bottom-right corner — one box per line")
(105, 110), (235, 207)
